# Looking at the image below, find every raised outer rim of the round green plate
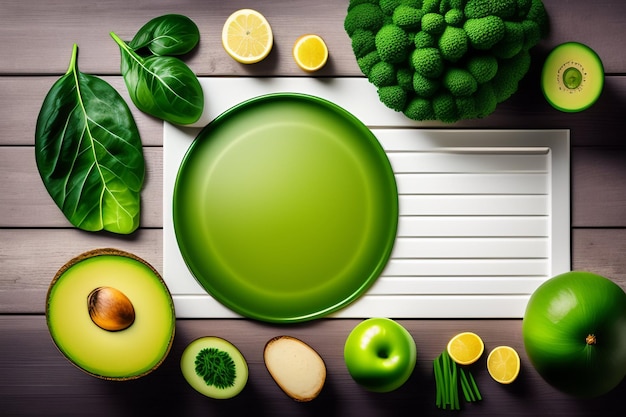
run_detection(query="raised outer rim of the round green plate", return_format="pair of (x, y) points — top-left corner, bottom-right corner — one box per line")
(172, 92), (399, 323)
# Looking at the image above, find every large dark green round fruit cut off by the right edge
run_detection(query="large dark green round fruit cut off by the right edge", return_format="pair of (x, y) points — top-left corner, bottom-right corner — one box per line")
(522, 271), (626, 397)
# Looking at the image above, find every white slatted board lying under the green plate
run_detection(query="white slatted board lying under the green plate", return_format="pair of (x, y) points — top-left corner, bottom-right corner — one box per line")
(163, 78), (570, 318)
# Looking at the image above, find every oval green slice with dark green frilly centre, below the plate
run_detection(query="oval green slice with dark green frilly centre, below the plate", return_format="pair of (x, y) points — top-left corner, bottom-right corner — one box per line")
(180, 336), (248, 399)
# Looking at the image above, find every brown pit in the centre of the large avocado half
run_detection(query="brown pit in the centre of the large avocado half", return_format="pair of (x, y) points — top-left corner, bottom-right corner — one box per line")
(87, 287), (135, 332)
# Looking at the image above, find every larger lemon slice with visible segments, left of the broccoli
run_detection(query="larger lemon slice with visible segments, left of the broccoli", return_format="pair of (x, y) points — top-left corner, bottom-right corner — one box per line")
(222, 9), (274, 64)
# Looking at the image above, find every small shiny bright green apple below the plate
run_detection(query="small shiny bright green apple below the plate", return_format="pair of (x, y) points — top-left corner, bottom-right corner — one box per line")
(343, 317), (417, 392)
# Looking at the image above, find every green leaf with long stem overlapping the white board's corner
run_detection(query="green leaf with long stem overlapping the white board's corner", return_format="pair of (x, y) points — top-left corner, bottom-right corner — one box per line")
(111, 32), (204, 125)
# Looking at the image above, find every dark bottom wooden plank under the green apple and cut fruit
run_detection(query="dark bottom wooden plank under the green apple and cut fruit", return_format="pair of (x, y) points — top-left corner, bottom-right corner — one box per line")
(0, 316), (626, 417)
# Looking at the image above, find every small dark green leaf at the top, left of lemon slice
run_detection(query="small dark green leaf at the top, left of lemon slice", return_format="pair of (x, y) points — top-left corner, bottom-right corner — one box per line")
(128, 14), (200, 55)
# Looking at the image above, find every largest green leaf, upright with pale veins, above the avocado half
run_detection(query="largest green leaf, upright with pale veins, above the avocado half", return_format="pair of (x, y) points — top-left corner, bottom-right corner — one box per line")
(35, 44), (145, 234)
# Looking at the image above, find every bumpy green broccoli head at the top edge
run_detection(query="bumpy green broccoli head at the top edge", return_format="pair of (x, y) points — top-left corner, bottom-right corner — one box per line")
(344, 0), (549, 123)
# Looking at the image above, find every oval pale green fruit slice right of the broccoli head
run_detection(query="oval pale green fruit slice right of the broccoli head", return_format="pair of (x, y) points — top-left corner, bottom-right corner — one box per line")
(541, 42), (604, 112)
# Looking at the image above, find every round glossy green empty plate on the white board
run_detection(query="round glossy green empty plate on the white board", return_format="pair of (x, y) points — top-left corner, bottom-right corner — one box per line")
(173, 93), (398, 322)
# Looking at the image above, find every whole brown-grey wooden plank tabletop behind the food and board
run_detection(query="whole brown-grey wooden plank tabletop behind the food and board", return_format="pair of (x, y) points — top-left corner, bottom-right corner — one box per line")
(0, 0), (626, 417)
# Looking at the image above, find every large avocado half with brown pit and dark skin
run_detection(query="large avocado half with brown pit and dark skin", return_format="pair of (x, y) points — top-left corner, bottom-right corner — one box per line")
(46, 248), (176, 380)
